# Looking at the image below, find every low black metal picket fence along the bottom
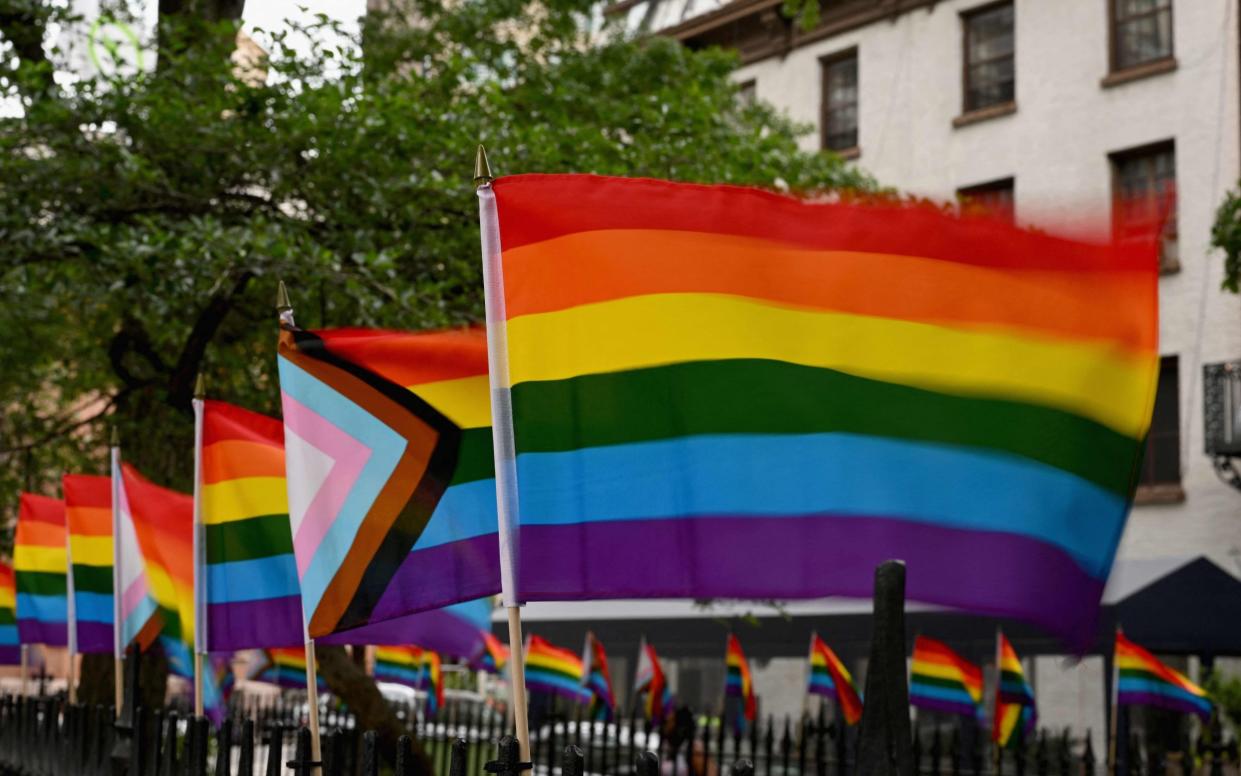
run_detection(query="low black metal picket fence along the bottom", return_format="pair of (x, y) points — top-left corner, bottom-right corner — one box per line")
(0, 698), (1237, 776)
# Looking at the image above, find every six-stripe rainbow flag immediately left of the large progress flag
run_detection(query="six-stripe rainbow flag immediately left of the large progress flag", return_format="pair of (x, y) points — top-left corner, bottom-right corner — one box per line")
(200, 400), (304, 652)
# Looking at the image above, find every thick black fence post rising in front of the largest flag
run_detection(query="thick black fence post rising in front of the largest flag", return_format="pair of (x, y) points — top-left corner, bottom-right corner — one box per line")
(858, 560), (912, 776)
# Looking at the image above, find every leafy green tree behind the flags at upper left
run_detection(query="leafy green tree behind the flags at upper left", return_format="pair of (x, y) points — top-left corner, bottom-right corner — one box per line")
(0, 0), (875, 759)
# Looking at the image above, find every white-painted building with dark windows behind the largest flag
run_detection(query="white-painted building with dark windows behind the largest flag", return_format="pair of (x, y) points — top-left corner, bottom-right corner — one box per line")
(555, 0), (1241, 751)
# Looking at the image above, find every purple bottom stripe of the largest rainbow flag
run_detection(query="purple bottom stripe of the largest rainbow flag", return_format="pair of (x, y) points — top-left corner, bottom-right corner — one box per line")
(513, 515), (1103, 649)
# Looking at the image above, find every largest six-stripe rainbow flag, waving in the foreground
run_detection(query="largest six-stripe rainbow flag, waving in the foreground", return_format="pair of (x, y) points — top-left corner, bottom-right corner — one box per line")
(480, 175), (1159, 644)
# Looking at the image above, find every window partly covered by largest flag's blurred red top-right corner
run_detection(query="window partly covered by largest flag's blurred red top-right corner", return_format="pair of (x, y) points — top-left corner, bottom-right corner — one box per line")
(1112, 140), (1180, 272)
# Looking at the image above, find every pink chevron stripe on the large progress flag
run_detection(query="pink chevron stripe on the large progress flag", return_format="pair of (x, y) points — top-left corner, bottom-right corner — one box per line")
(280, 391), (371, 576)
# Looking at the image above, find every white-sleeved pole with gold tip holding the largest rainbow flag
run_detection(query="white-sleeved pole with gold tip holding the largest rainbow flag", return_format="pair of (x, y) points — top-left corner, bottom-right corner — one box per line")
(474, 145), (530, 762)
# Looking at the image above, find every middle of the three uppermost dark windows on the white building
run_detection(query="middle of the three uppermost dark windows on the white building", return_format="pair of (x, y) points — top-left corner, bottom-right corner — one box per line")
(962, 2), (1016, 113)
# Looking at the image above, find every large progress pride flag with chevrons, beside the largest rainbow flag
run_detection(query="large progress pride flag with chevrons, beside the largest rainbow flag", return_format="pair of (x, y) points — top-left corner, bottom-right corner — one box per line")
(279, 329), (500, 640)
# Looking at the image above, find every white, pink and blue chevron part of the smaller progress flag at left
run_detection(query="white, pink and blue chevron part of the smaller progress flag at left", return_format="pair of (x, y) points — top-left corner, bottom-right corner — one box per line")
(112, 447), (162, 657)
